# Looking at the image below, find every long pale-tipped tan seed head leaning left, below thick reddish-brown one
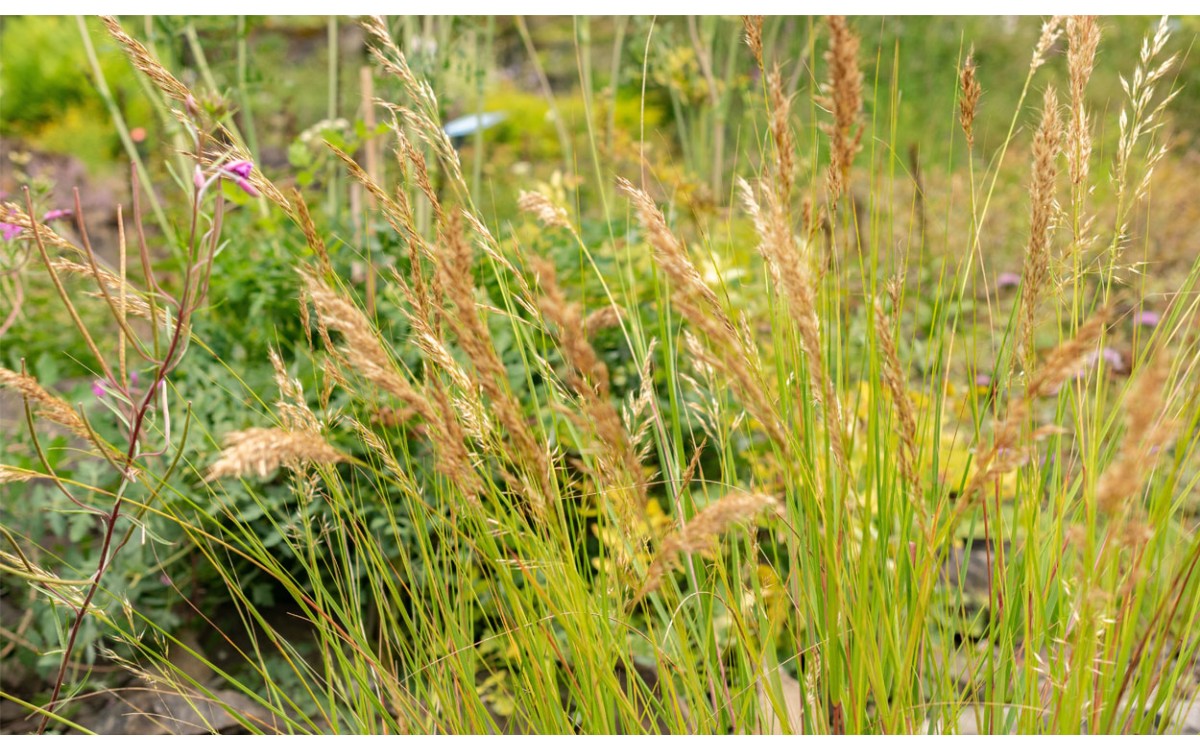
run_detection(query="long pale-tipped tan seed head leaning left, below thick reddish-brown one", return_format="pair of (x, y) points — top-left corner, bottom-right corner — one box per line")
(738, 180), (846, 468)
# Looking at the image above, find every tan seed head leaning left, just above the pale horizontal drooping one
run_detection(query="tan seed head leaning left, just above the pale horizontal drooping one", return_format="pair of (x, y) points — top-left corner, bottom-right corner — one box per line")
(301, 269), (432, 419)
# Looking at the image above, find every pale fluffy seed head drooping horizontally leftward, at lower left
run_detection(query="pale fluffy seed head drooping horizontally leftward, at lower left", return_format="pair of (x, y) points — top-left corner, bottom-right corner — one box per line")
(205, 427), (346, 481)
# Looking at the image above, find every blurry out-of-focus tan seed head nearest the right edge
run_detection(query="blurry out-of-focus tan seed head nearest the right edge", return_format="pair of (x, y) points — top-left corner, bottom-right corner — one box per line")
(1096, 354), (1177, 514)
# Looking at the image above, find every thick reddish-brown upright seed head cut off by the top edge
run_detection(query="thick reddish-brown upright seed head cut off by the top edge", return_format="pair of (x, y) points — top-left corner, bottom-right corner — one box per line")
(821, 16), (863, 198)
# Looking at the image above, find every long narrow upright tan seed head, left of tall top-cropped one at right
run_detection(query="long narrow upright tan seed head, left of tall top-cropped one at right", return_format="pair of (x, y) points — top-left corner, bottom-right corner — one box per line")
(1019, 86), (1062, 356)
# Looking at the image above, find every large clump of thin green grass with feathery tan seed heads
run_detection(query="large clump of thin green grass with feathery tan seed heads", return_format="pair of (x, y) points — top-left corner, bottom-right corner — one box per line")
(0, 17), (1200, 733)
